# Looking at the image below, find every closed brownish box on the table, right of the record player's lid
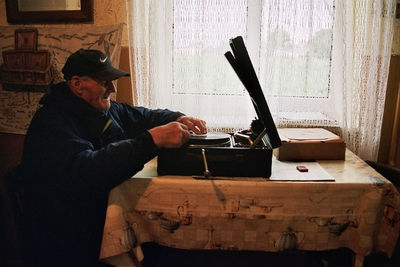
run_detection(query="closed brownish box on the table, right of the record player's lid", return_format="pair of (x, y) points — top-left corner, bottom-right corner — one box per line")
(274, 128), (346, 161)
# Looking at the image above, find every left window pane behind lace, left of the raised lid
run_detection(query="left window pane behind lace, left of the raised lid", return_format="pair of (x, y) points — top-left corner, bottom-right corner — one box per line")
(173, 0), (247, 95)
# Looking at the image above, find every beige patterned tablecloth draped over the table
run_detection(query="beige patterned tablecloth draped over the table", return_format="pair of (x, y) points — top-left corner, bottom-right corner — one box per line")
(100, 151), (400, 266)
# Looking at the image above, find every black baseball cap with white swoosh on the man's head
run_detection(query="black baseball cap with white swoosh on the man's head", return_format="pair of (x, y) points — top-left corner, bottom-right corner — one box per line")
(62, 49), (130, 81)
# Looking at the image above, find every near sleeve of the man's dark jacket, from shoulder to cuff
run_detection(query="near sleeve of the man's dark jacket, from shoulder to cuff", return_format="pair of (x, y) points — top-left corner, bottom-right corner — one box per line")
(22, 108), (158, 195)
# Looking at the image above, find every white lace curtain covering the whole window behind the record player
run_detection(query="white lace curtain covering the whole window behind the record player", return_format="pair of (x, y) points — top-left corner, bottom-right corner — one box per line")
(127, 0), (395, 159)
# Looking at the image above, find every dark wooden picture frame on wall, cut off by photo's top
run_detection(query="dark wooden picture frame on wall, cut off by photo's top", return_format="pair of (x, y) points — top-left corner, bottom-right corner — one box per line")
(6, 0), (93, 24)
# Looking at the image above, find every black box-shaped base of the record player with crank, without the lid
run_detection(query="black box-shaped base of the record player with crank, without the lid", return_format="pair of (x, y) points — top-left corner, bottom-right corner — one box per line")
(157, 134), (272, 178)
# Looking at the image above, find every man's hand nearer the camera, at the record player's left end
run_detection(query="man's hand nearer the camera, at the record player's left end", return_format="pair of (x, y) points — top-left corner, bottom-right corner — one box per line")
(149, 121), (190, 148)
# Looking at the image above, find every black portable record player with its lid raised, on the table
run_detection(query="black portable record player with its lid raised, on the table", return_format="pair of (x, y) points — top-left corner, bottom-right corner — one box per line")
(157, 36), (281, 179)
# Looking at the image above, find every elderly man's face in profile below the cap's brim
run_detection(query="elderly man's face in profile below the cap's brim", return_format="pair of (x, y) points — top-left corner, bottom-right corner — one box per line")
(80, 77), (115, 110)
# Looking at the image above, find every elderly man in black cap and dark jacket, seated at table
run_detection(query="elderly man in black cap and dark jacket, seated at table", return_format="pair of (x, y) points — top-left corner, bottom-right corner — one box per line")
(20, 49), (206, 267)
